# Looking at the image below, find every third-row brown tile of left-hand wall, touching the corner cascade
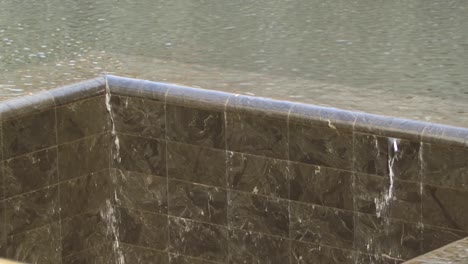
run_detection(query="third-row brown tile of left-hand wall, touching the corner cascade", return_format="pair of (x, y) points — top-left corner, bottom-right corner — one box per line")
(60, 170), (112, 218)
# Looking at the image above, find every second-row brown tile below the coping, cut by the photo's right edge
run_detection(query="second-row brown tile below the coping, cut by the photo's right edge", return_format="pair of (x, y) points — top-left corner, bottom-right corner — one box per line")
(422, 185), (468, 232)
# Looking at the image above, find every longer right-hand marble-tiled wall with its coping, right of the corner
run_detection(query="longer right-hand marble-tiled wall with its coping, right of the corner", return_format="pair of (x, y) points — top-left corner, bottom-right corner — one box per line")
(108, 77), (468, 264)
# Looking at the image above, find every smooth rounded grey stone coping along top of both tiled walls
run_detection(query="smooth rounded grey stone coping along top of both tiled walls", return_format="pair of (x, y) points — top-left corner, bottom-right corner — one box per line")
(0, 75), (468, 148)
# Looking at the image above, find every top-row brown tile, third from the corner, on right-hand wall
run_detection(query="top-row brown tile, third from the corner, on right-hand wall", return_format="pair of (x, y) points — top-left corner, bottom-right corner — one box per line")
(226, 111), (288, 160)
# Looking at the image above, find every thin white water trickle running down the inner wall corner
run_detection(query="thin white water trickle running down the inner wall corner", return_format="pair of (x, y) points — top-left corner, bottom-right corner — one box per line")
(101, 79), (125, 264)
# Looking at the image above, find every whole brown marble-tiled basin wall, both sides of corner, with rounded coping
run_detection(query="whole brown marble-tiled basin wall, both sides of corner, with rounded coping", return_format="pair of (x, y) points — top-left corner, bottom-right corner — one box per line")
(0, 76), (468, 264)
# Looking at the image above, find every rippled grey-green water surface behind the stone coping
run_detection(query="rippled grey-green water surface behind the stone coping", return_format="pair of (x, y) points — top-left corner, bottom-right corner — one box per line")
(0, 0), (468, 124)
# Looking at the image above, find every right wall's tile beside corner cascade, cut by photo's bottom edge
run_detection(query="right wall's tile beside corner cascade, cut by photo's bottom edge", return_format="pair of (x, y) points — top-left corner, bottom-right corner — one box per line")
(120, 243), (169, 264)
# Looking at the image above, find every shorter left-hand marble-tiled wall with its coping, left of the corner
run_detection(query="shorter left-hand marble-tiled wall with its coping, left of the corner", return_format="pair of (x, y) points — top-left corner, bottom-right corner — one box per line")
(0, 77), (112, 263)
